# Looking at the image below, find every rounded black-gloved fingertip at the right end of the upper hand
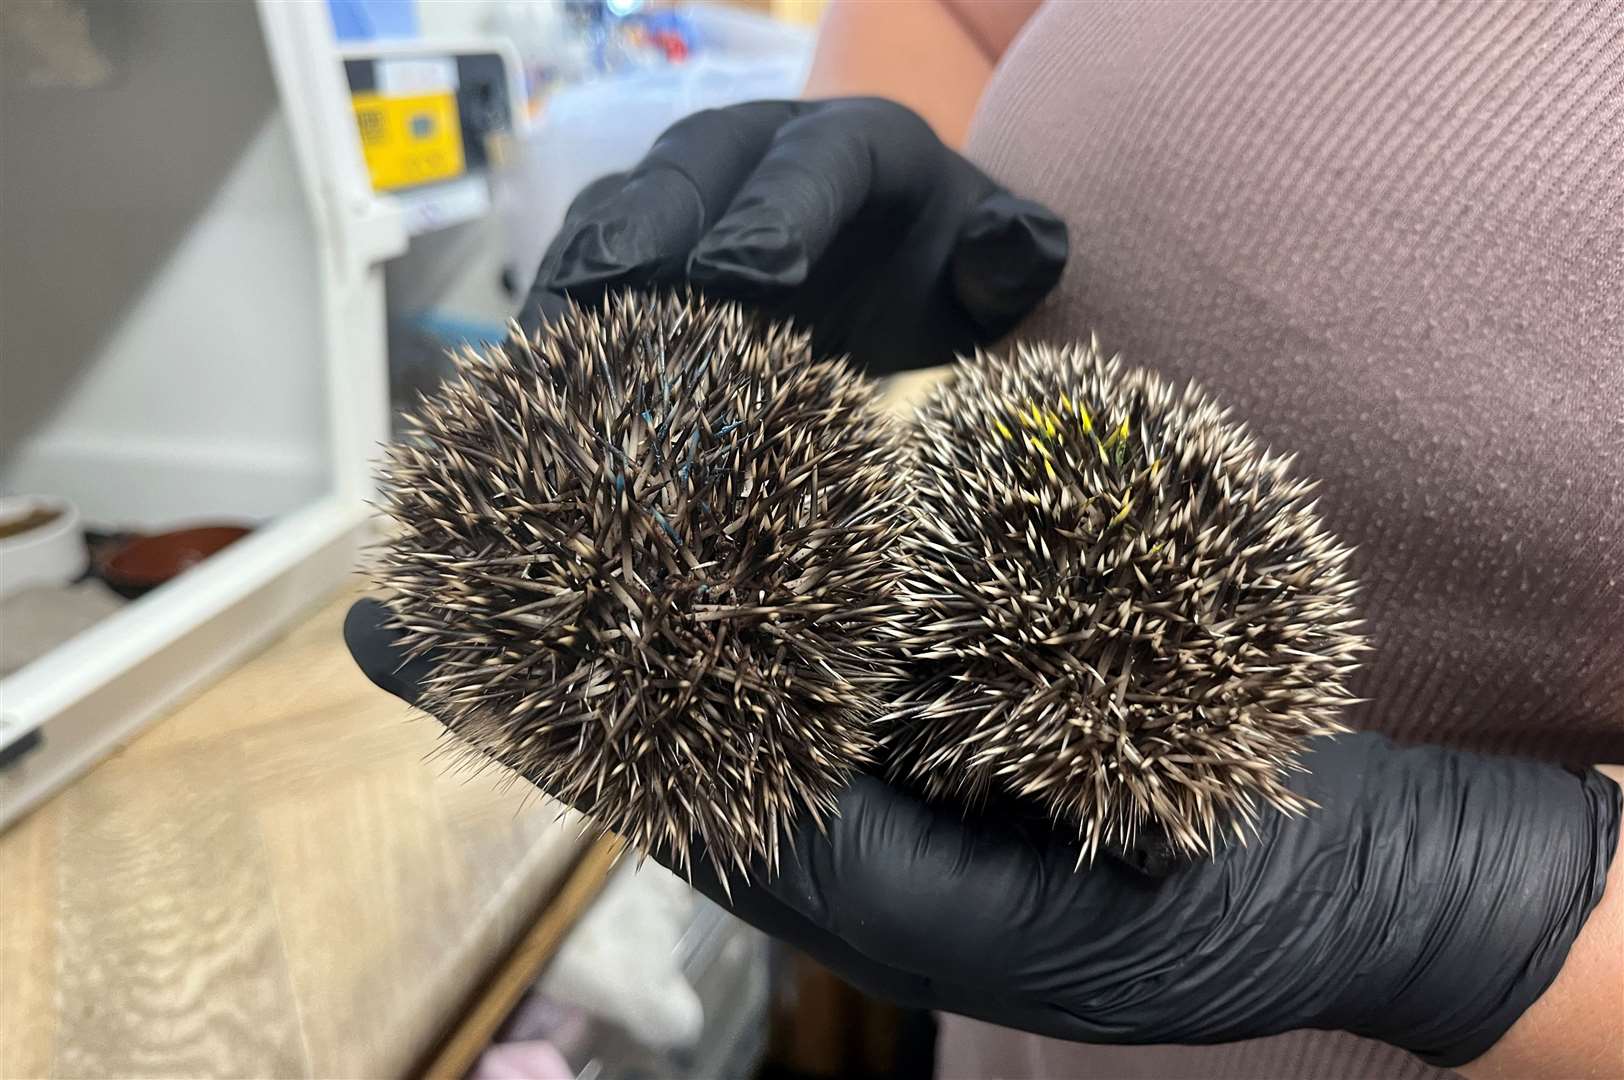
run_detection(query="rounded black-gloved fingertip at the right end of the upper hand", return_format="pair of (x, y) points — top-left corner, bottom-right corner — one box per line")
(948, 192), (1070, 339)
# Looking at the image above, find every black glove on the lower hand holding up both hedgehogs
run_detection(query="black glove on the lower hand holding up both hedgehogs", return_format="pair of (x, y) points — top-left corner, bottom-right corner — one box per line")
(344, 601), (1619, 1065)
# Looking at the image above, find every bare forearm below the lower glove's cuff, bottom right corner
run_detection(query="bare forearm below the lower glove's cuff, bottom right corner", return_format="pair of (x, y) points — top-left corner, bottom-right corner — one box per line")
(1458, 765), (1624, 1080)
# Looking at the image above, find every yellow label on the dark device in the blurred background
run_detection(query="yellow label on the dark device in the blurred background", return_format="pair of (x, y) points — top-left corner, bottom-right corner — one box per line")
(351, 91), (464, 192)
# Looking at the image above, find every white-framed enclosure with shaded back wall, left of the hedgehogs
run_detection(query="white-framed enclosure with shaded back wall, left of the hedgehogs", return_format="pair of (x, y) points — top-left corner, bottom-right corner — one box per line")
(0, 0), (406, 827)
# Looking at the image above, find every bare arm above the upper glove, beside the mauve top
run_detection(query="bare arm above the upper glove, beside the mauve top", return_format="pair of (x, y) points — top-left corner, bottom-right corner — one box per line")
(806, 0), (1038, 146)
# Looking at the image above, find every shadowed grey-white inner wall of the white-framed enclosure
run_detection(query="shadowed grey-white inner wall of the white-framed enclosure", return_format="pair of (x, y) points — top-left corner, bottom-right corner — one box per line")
(0, 0), (326, 528)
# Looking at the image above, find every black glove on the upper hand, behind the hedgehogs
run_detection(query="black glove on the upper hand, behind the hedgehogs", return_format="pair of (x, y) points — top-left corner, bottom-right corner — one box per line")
(520, 97), (1067, 375)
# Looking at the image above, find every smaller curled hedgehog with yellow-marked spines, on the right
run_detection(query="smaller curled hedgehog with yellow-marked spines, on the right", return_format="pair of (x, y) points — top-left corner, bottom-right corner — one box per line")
(888, 339), (1366, 864)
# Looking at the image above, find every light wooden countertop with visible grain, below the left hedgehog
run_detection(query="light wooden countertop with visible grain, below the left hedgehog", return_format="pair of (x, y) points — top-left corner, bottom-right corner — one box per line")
(0, 591), (597, 1077)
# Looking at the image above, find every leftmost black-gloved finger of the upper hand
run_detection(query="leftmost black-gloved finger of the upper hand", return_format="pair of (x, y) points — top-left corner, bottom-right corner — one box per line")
(538, 101), (801, 300)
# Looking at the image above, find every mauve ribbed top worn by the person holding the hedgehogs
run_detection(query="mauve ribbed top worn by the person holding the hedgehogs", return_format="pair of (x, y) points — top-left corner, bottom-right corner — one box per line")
(939, 0), (1624, 1080)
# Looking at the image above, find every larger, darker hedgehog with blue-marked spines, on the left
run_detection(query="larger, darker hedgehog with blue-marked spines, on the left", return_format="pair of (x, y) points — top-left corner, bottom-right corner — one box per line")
(377, 292), (906, 883)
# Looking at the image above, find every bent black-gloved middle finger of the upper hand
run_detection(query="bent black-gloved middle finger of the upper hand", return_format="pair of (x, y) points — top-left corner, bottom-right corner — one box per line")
(687, 99), (942, 299)
